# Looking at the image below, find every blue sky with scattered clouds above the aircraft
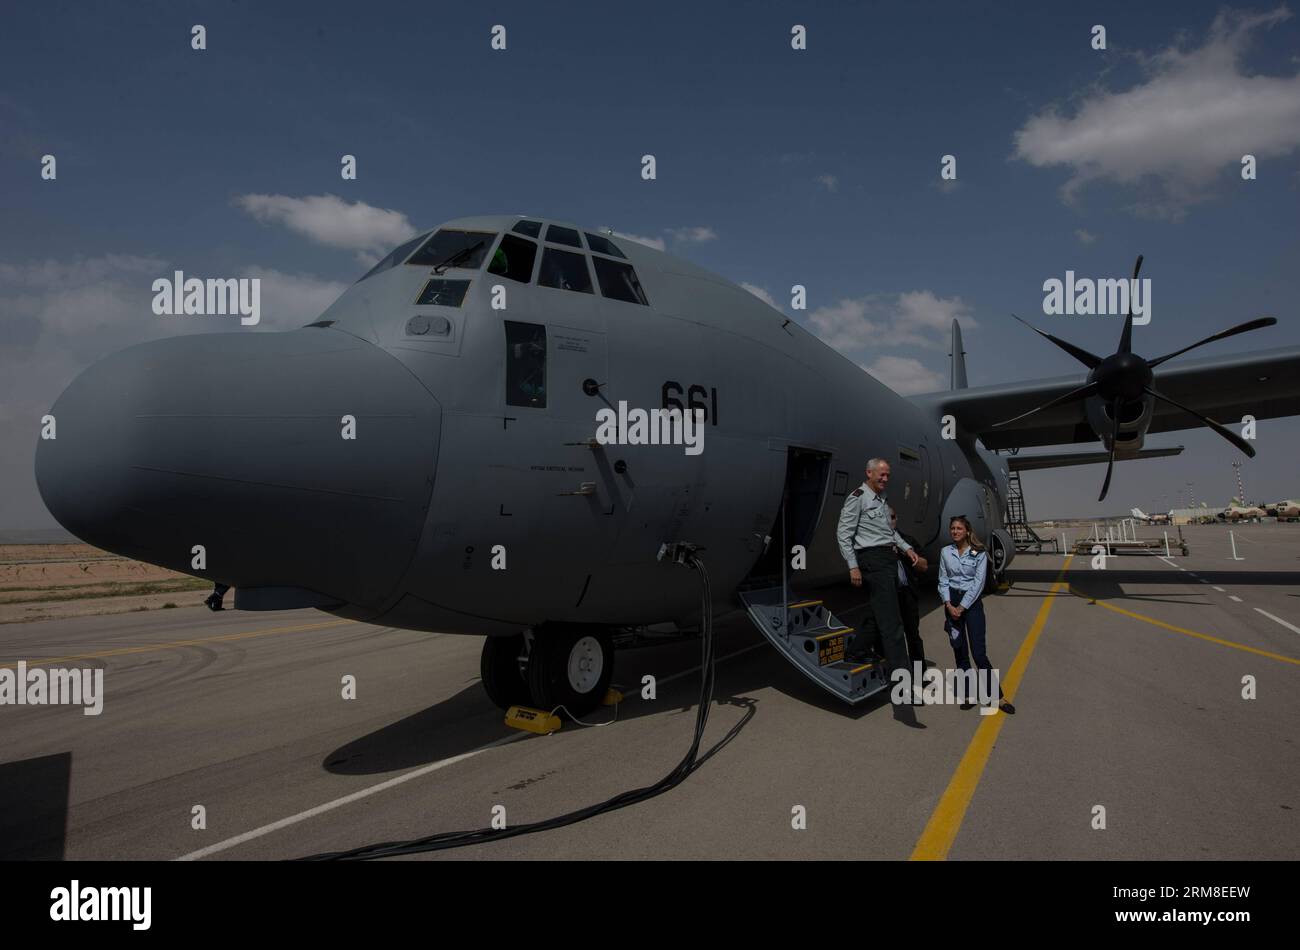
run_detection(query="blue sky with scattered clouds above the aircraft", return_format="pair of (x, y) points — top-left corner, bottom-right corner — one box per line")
(0, 3), (1300, 528)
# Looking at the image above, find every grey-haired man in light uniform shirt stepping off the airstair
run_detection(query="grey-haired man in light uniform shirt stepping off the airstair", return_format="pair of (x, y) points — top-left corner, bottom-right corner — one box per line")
(836, 459), (919, 687)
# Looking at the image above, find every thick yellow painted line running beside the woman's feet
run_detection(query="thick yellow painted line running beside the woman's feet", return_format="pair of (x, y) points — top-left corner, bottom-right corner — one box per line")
(911, 555), (1074, 860)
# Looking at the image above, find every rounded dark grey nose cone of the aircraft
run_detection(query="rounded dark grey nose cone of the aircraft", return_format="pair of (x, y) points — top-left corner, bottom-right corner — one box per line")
(36, 329), (441, 608)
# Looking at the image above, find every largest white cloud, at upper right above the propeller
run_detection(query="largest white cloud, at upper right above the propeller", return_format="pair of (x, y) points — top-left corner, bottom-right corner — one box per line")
(1015, 6), (1300, 218)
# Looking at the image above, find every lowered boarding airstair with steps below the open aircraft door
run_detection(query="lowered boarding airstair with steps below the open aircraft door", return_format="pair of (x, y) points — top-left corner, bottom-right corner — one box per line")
(740, 586), (889, 703)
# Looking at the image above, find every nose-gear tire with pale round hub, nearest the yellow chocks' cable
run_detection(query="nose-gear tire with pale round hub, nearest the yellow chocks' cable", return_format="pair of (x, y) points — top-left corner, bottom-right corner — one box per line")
(528, 626), (614, 719)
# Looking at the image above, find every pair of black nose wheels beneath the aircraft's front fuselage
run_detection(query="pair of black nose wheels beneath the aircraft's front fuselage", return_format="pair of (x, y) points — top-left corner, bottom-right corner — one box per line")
(480, 625), (614, 719)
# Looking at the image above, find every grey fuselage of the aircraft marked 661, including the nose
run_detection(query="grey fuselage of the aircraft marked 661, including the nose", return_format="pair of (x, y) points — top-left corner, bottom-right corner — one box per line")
(27, 216), (1011, 634)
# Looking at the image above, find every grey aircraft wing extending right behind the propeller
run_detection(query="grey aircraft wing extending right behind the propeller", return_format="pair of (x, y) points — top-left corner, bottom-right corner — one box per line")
(913, 347), (1300, 448)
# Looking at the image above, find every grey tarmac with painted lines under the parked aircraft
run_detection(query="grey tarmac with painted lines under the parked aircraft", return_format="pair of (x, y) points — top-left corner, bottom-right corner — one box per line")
(0, 524), (1300, 860)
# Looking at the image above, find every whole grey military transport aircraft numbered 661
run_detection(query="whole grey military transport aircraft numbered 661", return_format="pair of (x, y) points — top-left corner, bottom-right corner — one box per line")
(36, 216), (1300, 716)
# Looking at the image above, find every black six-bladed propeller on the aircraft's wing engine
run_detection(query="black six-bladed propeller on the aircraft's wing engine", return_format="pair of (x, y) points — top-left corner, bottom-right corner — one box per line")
(993, 255), (1278, 502)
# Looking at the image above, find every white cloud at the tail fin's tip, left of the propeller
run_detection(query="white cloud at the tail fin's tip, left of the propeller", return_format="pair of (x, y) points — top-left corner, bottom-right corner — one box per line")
(809, 290), (978, 353)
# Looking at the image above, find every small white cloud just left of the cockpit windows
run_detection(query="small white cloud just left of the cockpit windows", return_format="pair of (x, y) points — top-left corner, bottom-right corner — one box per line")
(235, 195), (416, 265)
